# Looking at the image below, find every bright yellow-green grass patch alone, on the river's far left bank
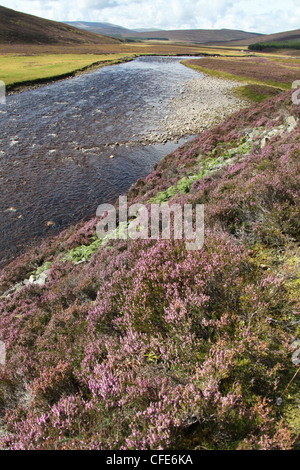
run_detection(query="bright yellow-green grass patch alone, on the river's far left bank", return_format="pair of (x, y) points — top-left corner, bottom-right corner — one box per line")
(0, 54), (135, 91)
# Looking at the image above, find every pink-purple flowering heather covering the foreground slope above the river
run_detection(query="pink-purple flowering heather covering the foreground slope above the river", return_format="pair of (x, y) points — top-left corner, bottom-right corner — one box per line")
(0, 92), (300, 450)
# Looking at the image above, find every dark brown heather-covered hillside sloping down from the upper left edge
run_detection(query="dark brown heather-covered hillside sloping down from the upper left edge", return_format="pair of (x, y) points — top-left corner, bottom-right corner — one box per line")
(0, 6), (119, 44)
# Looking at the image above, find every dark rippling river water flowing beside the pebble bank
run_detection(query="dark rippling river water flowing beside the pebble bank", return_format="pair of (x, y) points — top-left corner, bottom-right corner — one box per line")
(0, 57), (203, 266)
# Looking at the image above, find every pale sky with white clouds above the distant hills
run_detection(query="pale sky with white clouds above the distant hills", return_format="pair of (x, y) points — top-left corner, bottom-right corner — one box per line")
(0, 0), (300, 34)
